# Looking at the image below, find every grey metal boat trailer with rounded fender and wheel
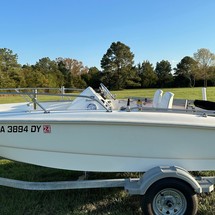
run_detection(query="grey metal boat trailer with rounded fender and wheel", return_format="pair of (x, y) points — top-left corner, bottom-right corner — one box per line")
(0, 166), (215, 215)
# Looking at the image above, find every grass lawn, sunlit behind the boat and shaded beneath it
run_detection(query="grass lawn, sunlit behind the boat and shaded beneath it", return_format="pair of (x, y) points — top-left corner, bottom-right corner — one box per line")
(0, 87), (215, 215)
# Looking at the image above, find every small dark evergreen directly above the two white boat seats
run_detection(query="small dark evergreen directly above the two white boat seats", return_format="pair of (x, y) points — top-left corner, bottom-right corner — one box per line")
(155, 60), (173, 87)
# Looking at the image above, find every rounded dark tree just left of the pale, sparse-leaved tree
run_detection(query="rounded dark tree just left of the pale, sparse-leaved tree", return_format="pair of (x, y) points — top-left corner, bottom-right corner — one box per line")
(174, 56), (198, 87)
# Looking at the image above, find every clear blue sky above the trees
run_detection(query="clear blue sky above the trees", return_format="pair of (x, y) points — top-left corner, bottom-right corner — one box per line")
(0, 0), (215, 69)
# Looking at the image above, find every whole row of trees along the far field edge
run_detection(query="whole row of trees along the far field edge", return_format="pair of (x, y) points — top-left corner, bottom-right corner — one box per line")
(0, 42), (215, 90)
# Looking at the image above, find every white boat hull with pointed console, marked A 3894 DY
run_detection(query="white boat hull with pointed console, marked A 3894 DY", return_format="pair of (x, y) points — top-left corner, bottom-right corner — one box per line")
(0, 85), (215, 172)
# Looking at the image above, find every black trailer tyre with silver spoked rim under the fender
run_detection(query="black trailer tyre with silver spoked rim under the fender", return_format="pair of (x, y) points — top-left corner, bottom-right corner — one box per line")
(141, 178), (198, 215)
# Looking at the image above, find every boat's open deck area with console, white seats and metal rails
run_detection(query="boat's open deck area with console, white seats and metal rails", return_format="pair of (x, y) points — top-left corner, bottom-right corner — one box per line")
(0, 83), (212, 114)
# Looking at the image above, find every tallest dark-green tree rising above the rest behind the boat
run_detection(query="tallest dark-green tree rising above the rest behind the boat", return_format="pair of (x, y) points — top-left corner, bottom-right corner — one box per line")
(101, 42), (138, 90)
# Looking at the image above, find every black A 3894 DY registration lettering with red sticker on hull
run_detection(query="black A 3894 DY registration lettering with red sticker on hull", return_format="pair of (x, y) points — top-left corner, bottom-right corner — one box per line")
(0, 125), (51, 134)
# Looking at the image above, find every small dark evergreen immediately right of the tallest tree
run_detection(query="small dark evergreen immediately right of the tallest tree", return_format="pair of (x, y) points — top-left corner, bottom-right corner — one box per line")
(138, 61), (158, 87)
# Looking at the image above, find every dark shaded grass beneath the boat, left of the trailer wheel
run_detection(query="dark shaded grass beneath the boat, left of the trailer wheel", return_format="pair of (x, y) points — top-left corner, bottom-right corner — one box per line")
(0, 159), (142, 215)
